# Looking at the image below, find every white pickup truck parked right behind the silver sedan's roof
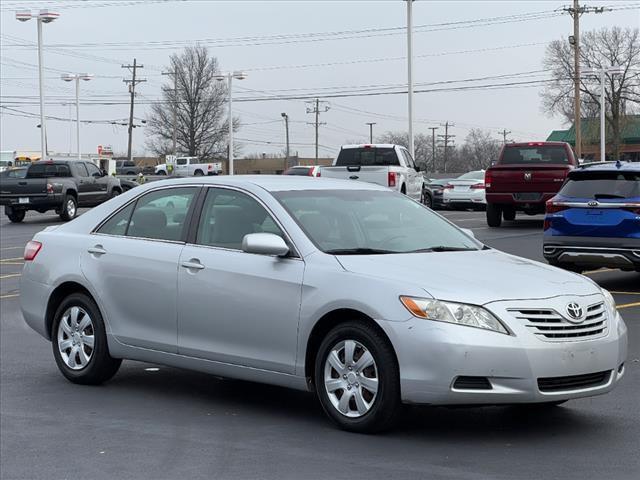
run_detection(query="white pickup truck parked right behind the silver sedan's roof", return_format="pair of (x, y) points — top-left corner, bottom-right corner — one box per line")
(321, 144), (424, 201)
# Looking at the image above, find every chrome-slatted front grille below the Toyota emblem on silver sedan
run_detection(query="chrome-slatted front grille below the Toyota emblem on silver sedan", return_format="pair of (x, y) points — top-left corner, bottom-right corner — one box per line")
(509, 302), (607, 342)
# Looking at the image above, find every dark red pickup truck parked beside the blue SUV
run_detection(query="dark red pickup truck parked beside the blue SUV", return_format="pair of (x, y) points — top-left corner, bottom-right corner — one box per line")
(484, 142), (578, 227)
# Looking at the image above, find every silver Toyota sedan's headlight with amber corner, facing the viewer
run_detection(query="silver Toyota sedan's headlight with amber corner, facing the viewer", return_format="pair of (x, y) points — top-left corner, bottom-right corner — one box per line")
(400, 297), (509, 335)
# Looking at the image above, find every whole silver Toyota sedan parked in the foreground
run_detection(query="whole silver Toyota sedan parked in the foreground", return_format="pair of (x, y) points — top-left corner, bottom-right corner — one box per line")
(20, 176), (627, 432)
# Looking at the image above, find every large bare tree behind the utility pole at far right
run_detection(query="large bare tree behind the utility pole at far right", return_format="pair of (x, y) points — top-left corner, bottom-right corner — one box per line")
(541, 27), (640, 158)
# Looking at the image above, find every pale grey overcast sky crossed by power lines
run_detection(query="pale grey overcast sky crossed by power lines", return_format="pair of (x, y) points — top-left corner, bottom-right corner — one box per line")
(0, 0), (640, 156)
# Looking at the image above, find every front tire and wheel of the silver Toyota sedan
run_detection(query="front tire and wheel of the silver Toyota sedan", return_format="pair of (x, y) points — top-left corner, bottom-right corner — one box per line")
(314, 322), (401, 433)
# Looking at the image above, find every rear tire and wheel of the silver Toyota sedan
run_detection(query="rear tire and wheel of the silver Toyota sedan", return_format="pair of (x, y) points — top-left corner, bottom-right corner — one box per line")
(51, 293), (122, 385)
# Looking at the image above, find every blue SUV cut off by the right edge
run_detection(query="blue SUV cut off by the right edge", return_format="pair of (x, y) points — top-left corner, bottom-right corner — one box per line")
(543, 161), (640, 272)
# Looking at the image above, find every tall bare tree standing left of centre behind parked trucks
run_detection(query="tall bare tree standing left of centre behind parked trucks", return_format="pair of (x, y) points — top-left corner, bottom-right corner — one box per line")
(147, 46), (237, 158)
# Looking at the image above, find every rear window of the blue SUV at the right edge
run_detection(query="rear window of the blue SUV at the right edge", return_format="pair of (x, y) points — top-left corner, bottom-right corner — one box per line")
(560, 172), (640, 199)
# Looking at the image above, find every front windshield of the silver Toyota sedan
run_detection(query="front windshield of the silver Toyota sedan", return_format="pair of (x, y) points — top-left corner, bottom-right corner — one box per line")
(273, 190), (482, 254)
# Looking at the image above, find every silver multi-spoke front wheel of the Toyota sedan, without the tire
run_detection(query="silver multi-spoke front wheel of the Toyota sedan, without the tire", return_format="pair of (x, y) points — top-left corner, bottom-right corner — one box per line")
(324, 340), (379, 418)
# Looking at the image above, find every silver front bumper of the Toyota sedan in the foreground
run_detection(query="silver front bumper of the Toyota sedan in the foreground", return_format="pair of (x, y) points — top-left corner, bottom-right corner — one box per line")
(380, 297), (627, 405)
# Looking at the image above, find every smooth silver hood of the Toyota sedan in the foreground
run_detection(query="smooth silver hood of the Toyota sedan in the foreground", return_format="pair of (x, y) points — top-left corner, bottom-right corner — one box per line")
(337, 250), (600, 305)
